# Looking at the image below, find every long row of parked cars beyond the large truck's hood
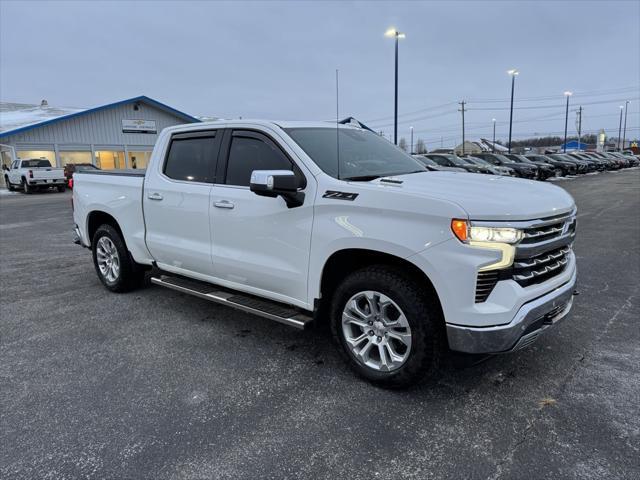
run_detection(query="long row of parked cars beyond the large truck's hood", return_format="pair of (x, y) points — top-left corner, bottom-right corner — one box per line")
(414, 152), (640, 180)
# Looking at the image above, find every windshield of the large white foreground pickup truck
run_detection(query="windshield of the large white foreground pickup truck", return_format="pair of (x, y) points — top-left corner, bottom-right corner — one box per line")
(285, 127), (428, 180)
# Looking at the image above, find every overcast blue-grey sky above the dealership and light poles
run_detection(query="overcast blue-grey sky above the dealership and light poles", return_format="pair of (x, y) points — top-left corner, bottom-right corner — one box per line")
(0, 0), (640, 148)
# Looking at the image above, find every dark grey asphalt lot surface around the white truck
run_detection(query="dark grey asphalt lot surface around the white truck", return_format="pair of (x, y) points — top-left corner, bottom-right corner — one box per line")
(0, 169), (640, 479)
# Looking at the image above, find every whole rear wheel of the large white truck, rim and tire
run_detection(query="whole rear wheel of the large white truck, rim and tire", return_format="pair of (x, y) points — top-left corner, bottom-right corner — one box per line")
(91, 225), (144, 293)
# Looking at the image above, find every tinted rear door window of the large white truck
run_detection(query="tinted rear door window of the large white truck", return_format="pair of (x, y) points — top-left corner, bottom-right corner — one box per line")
(163, 132), (218, 183)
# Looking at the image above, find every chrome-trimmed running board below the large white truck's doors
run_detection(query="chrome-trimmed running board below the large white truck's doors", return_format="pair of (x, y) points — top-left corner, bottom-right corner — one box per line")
(151, 275), (313, 330)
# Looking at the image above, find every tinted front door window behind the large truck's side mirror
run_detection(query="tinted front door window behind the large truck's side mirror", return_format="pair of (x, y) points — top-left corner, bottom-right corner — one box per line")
(225, 136), (293, 187)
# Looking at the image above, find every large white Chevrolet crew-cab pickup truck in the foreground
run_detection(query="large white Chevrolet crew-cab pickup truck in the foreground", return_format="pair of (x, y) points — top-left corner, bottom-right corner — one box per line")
(73, 120), (576, 387)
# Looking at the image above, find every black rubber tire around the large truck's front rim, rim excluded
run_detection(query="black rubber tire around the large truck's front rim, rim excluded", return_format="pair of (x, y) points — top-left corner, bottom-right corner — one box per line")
(330, 265), (446, 388)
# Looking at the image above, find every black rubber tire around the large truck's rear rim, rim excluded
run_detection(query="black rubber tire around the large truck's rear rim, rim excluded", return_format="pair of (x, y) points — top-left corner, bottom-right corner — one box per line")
(91, 224), (145, 293)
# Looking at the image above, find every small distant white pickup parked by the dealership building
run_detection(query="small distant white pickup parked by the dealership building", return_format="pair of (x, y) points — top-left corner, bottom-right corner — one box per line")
(4, 158), (67, 193)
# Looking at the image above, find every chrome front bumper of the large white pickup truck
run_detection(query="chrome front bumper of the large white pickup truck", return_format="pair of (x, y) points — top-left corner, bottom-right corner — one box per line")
(447, 270), (577, 353)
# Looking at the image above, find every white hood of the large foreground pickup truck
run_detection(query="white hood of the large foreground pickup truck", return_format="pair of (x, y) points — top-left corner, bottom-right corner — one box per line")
(371, 172), (575, 220)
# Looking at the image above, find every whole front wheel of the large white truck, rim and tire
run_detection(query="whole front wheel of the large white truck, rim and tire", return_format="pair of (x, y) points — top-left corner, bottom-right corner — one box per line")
(331, 266), (445, 388)
